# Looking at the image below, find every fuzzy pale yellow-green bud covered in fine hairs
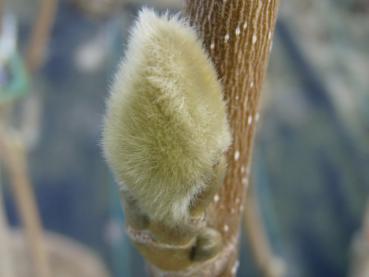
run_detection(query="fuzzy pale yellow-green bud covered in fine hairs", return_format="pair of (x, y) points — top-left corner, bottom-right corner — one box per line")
(103, 9), (231, 226)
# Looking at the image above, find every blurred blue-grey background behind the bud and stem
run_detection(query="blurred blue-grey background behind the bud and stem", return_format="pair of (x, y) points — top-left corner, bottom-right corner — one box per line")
(0, 0), (369, 277)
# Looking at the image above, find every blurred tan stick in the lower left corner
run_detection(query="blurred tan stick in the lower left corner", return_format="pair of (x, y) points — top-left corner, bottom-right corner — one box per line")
(0, 133), (51, 277)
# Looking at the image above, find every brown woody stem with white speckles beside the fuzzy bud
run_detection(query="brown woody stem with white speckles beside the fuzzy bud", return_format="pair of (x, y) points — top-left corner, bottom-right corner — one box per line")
(186, 0), (279, 276)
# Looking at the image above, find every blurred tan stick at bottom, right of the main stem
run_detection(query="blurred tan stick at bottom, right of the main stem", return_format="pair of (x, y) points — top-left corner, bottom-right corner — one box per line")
(244, 189), (285, 277)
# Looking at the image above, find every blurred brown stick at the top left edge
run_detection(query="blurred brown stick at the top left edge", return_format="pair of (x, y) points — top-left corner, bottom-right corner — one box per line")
(26, 0), (58, 72)
